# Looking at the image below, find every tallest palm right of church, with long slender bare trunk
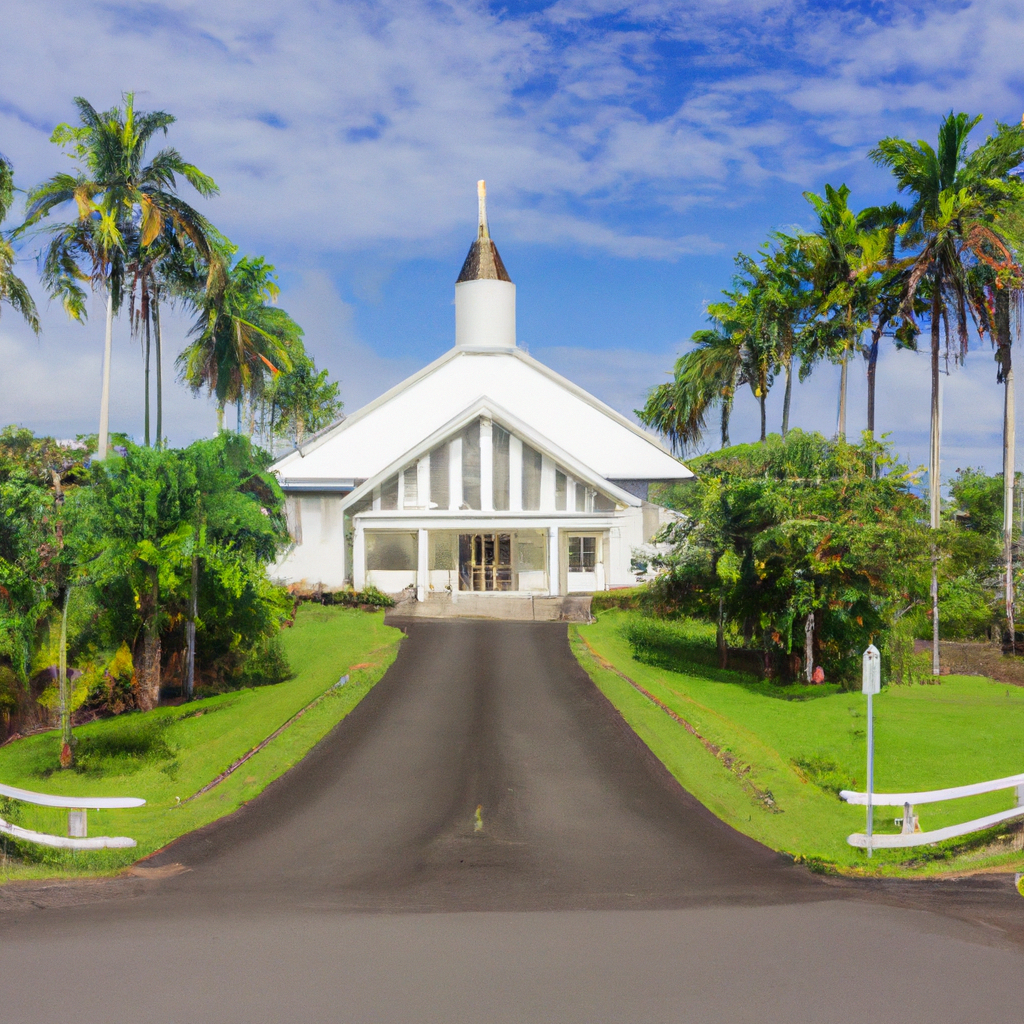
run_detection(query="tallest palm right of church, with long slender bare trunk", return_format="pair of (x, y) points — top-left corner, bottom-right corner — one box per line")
(871, 113), (1024, 675)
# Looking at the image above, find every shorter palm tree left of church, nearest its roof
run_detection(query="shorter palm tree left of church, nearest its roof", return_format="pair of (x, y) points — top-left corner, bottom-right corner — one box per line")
(177, 256), (302, 432)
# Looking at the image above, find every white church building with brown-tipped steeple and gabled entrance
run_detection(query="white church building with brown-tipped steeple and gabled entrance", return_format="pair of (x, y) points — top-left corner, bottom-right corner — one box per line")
(273, 181), (692, 610)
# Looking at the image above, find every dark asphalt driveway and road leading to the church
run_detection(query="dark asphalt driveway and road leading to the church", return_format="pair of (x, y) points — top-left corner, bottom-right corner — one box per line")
(0, 621), (1024, 1024)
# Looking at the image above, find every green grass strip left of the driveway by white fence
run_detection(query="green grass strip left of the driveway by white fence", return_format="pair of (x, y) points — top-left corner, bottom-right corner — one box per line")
(0, 604), (402, 881)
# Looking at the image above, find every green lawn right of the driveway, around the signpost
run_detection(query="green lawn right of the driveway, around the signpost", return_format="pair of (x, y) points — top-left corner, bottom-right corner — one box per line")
(569, 610), (1024, 873)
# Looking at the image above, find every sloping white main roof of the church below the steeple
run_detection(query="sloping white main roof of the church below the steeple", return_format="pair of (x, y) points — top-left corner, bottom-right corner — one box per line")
(273, 348), (693, 487)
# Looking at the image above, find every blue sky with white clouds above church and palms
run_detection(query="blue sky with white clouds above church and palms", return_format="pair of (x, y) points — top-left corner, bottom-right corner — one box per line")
(0, 0), (1024, 472)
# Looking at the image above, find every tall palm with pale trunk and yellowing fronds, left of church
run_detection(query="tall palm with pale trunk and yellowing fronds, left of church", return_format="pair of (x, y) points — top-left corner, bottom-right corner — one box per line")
(18, 92), (217, 459)
